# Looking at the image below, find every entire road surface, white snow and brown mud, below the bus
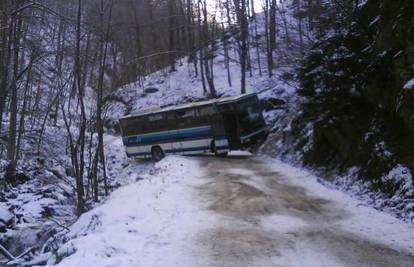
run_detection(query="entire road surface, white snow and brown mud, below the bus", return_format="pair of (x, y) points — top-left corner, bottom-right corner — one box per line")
(54, 155), (414, 267)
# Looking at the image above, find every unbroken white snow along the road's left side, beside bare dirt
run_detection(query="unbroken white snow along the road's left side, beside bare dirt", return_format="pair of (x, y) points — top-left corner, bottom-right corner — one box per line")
(47, 156), (209, 267)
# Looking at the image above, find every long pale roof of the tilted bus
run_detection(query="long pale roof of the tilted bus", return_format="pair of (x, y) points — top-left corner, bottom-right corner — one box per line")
(120, 93), (257, 120)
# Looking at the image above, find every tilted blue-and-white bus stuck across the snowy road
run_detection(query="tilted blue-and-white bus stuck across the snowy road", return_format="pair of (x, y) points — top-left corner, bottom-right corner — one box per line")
(119, 93), (269, 161)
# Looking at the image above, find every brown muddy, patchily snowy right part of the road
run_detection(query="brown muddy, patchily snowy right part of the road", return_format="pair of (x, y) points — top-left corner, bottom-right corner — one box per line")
(196, 157), (414, 266)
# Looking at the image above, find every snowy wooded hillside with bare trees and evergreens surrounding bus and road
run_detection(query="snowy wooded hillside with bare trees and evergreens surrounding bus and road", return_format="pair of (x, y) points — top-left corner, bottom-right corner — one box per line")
(0, 0), (414, 266)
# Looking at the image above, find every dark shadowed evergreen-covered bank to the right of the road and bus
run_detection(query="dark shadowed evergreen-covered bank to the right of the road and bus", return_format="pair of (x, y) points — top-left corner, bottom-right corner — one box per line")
(276, 0), (414, 218)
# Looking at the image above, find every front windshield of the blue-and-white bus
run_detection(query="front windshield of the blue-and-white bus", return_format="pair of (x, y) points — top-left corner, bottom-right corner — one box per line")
(238, 98), (262, 131)
